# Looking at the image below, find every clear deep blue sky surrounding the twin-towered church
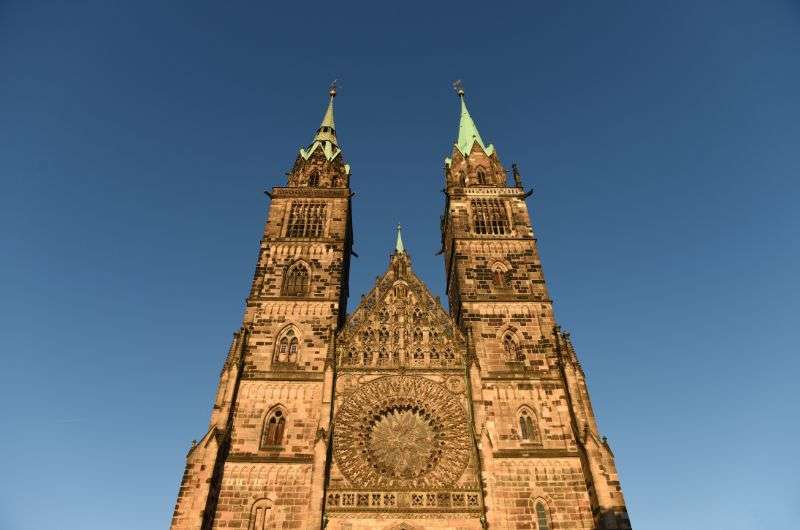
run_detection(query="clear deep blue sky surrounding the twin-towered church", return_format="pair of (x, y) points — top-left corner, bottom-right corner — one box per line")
(0, 0), (800, 530)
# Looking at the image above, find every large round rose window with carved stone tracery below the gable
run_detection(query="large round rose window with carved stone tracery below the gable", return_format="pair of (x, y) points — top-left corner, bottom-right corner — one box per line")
(333, 376), (470, 488)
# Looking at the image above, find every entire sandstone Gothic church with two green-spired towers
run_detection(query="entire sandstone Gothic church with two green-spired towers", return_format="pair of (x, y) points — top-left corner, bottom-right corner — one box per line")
(171, 89), (630, 530)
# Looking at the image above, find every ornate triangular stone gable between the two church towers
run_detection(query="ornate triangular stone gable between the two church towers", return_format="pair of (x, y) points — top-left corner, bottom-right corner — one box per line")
(336, 250), (466, 369)
